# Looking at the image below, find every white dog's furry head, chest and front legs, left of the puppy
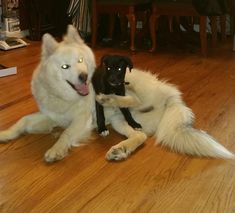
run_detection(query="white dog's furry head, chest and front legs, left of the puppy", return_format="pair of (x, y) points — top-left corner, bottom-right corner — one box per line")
(0, 26), (95, 162)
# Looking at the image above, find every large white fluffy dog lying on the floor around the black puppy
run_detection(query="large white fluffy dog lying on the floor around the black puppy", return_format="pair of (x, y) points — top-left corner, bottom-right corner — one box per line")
(0, 26), (234, 162)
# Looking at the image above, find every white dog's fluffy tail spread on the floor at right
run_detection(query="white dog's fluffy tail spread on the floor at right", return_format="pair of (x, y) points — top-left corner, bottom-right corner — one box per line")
(155, 97), (235, 158)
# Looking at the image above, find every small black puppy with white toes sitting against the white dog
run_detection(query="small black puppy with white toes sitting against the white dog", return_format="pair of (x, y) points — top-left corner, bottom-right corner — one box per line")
(92, 55), (141, 136)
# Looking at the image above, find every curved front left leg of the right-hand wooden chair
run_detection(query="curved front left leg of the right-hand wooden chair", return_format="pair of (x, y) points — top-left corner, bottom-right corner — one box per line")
(149, 8), (158, 52)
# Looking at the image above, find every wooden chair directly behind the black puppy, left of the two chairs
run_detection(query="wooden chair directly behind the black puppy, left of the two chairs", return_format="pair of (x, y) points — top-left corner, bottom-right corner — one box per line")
(91, 0), (150, 51)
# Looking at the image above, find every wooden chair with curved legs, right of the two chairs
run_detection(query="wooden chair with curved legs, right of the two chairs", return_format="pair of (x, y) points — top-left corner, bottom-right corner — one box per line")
(149, 0), (228, 56)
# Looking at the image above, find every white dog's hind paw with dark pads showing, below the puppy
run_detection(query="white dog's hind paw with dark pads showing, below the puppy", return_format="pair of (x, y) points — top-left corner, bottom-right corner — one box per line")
(106, 145), (130, 160)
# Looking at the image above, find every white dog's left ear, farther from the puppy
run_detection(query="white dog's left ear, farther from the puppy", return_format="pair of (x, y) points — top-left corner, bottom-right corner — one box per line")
(42, 33), (59, 57)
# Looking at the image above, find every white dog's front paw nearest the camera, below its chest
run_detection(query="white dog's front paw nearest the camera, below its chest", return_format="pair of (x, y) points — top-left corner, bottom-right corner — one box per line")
(44, 147), (68, 163)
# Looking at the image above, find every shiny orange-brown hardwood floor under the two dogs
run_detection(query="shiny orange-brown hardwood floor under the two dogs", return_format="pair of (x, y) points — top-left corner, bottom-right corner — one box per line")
(0, 38), (235, 213)
